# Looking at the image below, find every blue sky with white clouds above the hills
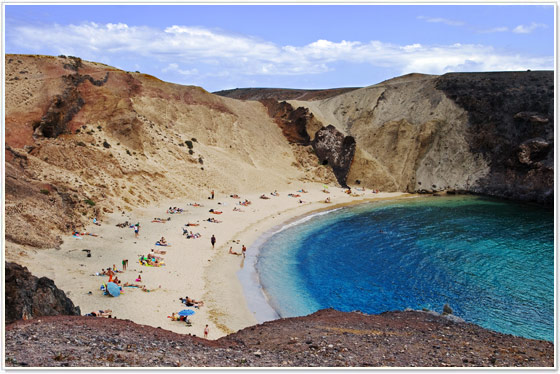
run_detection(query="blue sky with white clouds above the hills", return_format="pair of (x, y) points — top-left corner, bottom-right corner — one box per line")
(3, 3), (556, 92)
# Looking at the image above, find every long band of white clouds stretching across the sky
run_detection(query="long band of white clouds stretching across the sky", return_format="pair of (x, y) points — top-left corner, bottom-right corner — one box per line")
(9, 21), (553, 77)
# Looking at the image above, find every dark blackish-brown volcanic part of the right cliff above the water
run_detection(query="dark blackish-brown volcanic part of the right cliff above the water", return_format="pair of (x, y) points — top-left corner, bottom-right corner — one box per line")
(436, 71), (554, 204)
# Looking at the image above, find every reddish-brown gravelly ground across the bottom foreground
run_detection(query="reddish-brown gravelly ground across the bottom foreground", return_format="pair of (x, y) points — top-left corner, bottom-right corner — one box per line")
(5, 310), (554, 367)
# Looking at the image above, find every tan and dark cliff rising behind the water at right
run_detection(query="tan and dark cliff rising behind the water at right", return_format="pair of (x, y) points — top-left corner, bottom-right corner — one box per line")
(290, 71), (554, 204)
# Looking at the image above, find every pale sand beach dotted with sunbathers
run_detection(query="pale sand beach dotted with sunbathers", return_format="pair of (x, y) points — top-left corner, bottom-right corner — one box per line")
(7, 183), (406, 339)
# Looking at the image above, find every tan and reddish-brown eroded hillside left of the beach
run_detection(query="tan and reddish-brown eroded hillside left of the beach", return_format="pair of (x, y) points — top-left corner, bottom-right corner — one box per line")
(5, 55), (334, 247)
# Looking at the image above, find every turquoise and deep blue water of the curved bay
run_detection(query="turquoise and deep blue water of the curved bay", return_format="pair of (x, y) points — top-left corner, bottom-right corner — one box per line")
(256, 196), (554, 341)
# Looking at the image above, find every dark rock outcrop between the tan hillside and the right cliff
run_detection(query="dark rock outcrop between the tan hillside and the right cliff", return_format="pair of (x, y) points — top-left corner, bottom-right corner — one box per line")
(311, 125), (356, 187)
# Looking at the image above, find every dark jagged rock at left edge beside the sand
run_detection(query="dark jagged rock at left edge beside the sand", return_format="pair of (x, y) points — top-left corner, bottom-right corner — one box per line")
(4, 262), (80, 324)
